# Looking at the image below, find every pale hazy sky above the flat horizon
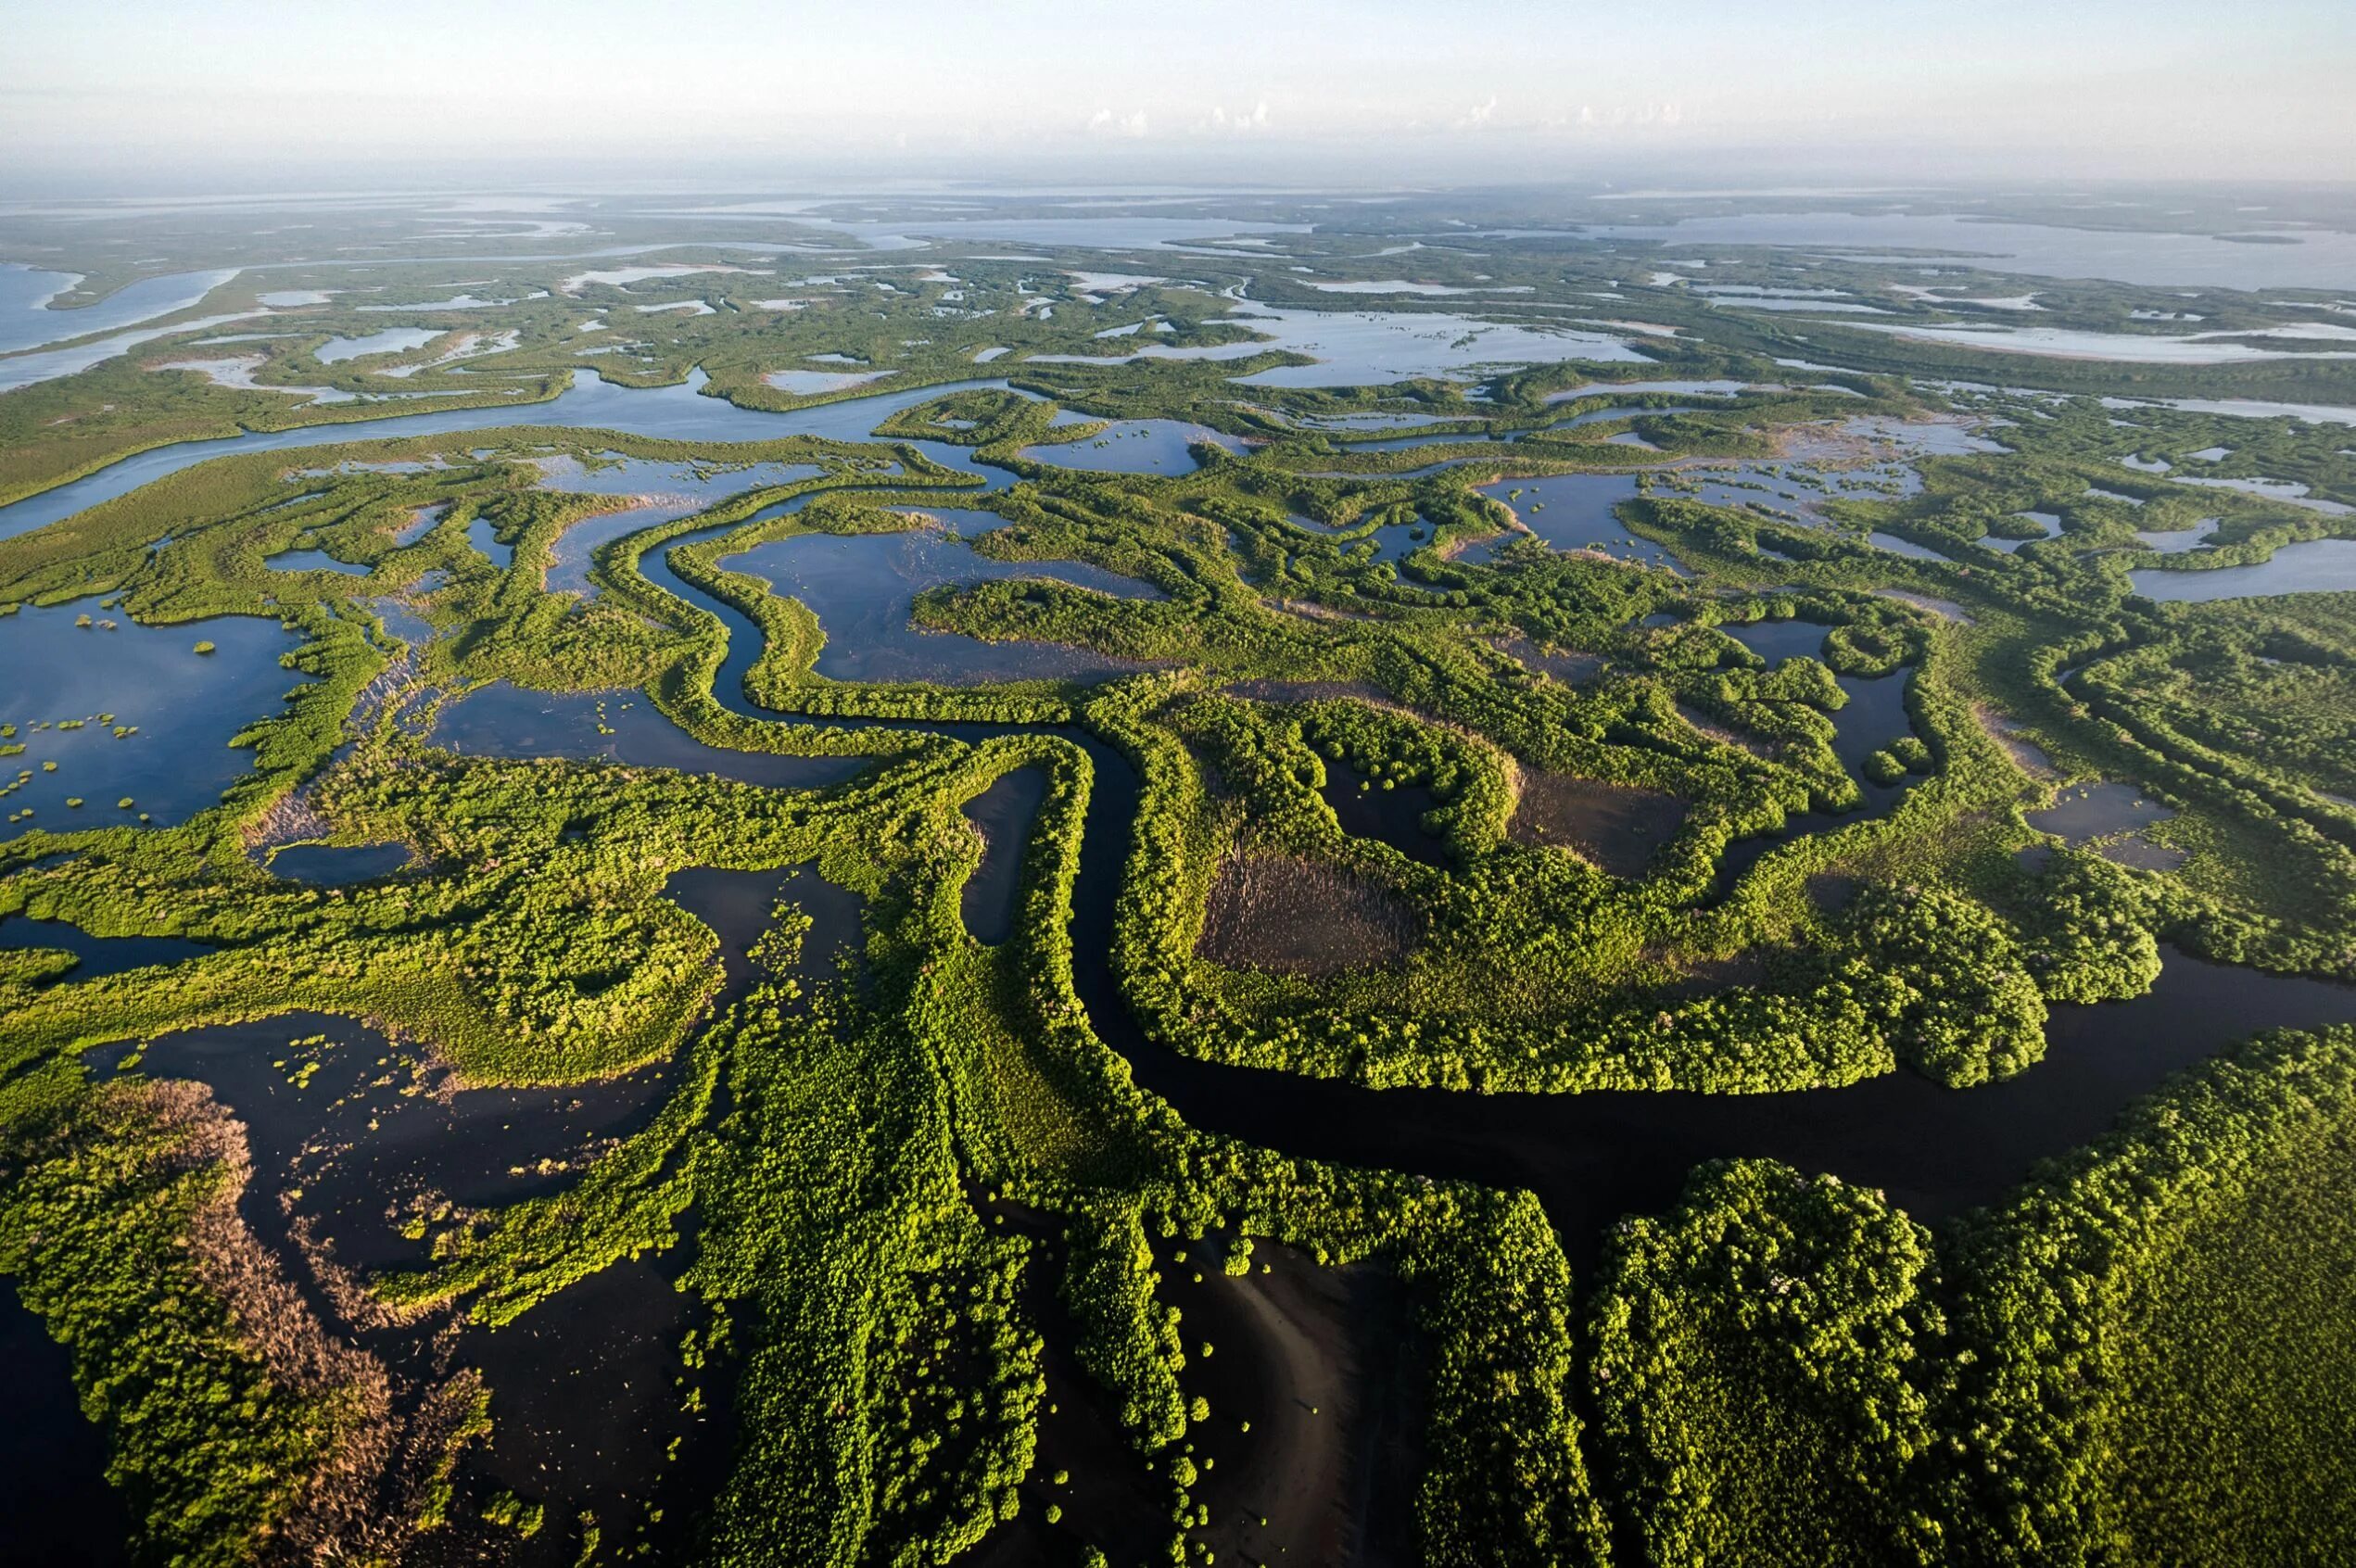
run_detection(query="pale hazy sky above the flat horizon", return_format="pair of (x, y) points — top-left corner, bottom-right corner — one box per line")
(0, 0), (2356, 188)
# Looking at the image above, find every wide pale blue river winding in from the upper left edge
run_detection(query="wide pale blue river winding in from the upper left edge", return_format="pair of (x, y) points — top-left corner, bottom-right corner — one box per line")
(0, 370), (1013, 539)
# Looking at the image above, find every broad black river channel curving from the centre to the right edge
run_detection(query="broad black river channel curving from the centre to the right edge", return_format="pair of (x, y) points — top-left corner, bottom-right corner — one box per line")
(1072, 740), (2356, 1267)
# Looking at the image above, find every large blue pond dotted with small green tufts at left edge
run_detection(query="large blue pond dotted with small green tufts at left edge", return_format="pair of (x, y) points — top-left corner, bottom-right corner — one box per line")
(0, 598), (309, 836)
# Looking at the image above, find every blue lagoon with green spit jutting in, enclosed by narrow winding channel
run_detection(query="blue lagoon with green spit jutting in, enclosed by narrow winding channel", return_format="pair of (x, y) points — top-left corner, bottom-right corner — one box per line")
(721, 530), (1161, 685)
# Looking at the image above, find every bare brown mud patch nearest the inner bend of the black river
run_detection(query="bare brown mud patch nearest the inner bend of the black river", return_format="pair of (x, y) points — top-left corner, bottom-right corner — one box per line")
(1195, 857), (1418, 975)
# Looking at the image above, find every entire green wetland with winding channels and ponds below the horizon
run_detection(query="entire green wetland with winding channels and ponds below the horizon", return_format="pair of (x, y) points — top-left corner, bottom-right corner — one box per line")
(0, 185), (2356, 1568)
